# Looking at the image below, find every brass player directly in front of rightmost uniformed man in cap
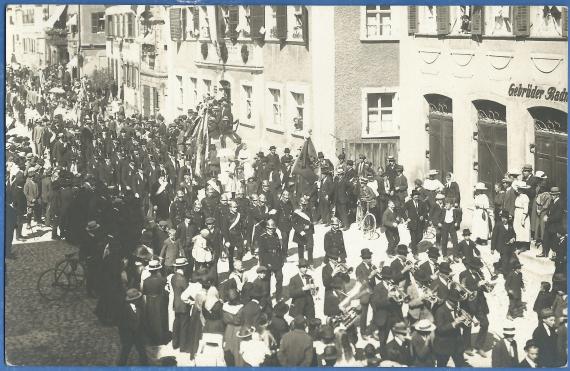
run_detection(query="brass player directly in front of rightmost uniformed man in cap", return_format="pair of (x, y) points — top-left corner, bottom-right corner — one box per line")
(322, 249), (350, 317)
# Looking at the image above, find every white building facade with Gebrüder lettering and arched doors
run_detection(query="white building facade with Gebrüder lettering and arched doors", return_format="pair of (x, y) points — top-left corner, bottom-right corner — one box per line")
(400, 6), (568, 208)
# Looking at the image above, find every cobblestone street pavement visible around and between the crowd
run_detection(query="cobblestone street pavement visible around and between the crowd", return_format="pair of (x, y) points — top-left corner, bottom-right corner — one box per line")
(5, 217), (554, 367)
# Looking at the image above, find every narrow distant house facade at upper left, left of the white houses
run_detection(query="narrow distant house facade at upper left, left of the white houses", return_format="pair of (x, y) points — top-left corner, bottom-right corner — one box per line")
(66, 5), (107, 78)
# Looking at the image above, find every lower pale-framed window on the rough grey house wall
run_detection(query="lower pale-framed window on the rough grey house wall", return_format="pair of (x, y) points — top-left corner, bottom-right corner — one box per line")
(362, 88), (399, 137)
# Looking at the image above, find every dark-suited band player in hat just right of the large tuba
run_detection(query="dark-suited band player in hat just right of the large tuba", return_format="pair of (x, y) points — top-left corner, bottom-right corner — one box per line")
(370, 266), (403, 348)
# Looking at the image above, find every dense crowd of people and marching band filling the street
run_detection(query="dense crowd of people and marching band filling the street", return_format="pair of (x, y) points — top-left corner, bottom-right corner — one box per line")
(6, 68), (567, 367)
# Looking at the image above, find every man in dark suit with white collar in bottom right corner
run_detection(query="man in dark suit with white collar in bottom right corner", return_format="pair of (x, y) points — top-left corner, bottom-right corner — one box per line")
(532, 308), (561, 367)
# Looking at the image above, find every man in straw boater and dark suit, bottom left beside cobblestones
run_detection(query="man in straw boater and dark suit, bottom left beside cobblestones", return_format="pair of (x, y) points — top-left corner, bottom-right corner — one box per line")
(117, 289), (148, 366)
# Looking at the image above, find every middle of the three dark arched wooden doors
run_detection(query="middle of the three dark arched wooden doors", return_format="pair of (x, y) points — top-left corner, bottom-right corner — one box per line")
(477, 121), (507, 202)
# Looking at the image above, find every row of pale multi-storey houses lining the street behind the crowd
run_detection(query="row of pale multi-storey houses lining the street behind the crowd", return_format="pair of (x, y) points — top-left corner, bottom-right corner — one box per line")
(6, 5), (568, 206)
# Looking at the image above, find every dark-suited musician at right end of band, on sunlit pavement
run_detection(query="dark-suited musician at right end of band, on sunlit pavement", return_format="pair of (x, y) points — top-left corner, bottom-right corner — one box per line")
(459, 257), (489, 358)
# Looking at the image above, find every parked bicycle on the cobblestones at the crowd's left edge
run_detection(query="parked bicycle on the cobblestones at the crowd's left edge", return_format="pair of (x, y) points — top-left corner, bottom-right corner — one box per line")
(36, 253), (85, 301)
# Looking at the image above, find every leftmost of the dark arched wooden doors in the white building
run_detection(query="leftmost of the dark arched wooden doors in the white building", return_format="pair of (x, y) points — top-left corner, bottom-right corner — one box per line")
(429, 115), (453, 183)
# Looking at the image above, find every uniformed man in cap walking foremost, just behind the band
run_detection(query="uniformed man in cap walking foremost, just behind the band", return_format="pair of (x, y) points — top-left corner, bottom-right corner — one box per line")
(256, 219), (283, 300)
